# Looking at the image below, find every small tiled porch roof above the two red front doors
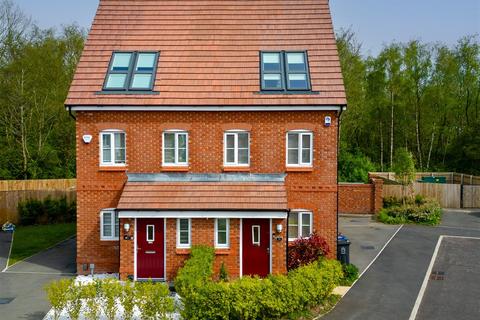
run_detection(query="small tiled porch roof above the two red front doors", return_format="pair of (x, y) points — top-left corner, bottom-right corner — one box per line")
(117, 182), (287, 210)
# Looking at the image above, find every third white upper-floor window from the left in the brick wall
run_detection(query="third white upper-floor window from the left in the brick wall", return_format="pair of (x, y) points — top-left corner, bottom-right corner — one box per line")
(223, 131), (250, 166)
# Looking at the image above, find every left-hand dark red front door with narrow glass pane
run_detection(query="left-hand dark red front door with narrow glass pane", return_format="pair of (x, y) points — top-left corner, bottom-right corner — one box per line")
(137, 219), (165, 279)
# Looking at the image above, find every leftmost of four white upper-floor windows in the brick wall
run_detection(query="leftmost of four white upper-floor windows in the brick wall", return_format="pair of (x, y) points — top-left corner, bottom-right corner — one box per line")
(100, 130), (127, 166)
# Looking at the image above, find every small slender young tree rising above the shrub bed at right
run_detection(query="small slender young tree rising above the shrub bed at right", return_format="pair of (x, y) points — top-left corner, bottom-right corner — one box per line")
(393, 148), (415, 204)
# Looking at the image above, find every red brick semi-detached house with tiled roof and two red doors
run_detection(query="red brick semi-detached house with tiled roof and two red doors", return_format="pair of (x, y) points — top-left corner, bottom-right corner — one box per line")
(65, 0), (346, 280)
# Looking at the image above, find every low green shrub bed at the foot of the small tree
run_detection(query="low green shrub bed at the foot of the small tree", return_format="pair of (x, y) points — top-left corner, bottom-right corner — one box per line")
(377, 197), (442, 225)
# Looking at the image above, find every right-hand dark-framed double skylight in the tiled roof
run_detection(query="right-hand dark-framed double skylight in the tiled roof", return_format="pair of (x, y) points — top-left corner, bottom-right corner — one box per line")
(260, 51), (311, 92)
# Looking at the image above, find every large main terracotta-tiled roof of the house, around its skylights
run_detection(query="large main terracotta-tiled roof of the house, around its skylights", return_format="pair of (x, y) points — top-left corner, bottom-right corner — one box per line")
(65, 0), (346, 106)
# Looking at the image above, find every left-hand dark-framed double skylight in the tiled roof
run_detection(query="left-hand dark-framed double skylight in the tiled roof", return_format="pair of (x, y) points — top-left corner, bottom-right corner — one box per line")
(103, 52), (158, 91)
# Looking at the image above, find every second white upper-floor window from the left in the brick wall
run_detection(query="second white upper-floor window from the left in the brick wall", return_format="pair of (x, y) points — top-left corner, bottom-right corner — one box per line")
(162, 130), (188, 166)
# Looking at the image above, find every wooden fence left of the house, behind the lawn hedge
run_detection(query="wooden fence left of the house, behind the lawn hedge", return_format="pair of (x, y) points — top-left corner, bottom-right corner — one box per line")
(0, 179), (76, 224)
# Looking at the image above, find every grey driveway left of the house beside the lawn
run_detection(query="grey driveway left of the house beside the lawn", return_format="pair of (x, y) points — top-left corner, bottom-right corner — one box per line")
(0, 238), (76, 320)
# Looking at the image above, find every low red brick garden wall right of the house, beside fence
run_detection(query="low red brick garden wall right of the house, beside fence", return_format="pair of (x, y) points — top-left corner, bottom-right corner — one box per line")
(338, 179), (383, 214)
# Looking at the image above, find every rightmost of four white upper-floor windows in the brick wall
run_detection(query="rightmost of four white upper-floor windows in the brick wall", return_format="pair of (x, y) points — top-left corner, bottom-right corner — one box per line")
(287, 130), (313, 167)
